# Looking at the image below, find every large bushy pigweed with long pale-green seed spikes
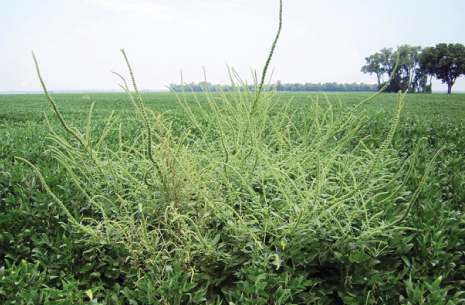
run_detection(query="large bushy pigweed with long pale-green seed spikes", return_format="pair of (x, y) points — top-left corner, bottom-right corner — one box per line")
(17, 0), (442, 303)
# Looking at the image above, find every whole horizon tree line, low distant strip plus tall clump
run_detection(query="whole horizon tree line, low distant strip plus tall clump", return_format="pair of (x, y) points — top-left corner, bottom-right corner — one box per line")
(170, 43), (465, 93)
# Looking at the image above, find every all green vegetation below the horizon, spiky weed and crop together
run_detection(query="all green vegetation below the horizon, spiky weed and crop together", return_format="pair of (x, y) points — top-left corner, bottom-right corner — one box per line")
(0, 0), (465, 304)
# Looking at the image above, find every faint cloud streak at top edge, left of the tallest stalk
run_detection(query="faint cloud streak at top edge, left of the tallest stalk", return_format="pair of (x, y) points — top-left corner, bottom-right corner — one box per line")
(87, 0), (172, 20)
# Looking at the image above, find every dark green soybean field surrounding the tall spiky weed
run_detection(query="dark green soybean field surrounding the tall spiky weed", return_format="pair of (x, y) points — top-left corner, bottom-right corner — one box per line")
(0, 92), (465, 304)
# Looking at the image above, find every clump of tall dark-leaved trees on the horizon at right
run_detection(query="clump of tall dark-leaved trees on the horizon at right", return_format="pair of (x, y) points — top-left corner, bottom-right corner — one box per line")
(361, 43), (465, 93)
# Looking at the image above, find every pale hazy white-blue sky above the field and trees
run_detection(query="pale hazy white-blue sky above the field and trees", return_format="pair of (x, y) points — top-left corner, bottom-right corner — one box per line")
(0, 0), (465, 92)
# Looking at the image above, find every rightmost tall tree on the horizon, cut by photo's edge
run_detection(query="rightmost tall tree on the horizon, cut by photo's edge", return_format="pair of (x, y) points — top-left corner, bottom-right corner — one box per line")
(420, 43), (465, 93)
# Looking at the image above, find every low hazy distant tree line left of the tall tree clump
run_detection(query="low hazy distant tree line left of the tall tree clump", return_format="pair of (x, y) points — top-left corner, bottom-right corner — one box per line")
(170, 82), (378, 92)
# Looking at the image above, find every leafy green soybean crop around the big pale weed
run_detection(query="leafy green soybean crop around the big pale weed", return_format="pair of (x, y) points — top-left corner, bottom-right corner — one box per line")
(0, 93), (465, 304)
